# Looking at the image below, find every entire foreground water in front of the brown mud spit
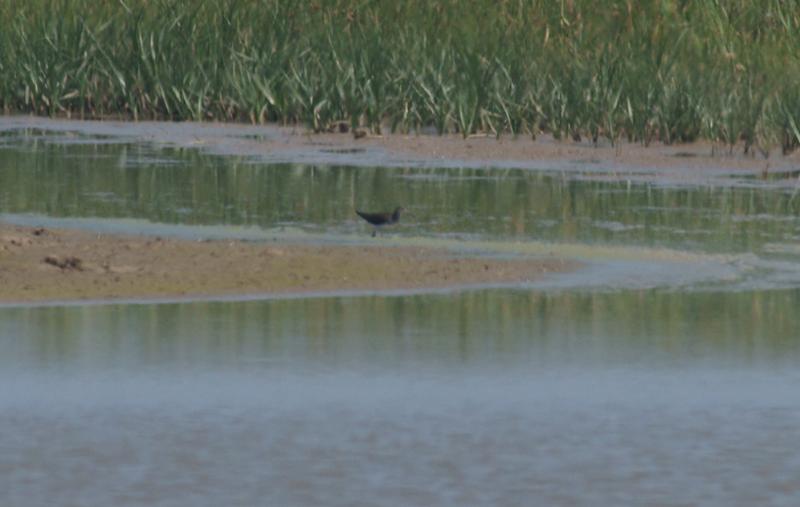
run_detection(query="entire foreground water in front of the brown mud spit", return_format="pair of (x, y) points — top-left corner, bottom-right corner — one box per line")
(0, 290), (800, 507)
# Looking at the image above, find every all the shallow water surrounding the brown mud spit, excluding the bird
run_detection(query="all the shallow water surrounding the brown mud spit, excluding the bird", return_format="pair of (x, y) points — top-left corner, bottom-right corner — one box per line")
(0, 126), (800, 506)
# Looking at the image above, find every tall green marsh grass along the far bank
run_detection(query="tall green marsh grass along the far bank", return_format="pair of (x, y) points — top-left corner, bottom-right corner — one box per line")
(0, 0), (800, 152)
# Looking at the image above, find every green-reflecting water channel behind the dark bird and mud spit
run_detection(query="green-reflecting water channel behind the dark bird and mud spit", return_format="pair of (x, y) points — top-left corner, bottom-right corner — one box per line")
(0, 130), (800, 252)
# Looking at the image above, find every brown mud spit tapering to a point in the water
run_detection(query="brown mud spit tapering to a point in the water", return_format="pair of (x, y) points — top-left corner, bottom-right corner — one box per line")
(0, 223), (577, 303)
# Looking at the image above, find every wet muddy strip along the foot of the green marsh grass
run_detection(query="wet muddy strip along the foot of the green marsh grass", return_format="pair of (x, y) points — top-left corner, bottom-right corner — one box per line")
(0, 116), (800, 186)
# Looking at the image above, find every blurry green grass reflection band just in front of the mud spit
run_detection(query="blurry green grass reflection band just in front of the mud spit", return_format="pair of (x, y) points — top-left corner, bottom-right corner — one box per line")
(0, 290), (800, 370)
